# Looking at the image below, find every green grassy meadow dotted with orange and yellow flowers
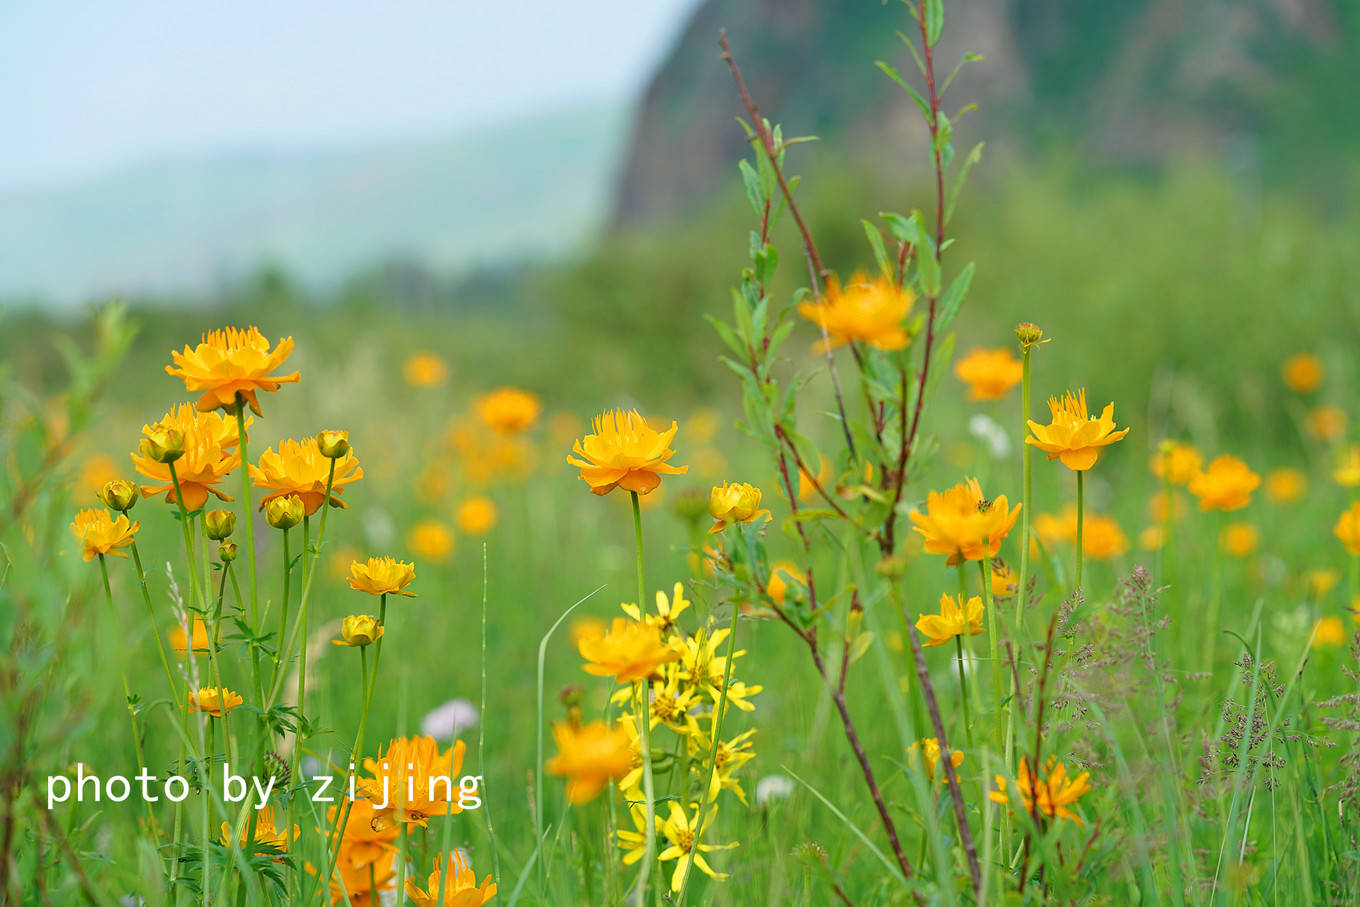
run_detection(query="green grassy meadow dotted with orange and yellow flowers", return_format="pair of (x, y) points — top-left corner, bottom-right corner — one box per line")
(0, 1), (1360, 907)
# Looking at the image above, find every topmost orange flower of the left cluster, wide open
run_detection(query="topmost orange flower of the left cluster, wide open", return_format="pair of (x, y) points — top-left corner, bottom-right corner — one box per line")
(166, 326), (299, 416)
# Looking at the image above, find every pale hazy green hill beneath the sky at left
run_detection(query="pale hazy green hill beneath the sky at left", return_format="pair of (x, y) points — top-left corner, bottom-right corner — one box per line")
(0, 107), (626, 307)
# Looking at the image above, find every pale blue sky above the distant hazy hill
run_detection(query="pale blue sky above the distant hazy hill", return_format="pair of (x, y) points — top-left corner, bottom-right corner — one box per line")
(0, 0), (698, 190)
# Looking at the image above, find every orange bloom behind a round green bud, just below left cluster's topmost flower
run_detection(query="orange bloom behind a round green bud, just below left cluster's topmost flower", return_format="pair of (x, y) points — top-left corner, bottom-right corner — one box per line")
(132, 404), (244, 513)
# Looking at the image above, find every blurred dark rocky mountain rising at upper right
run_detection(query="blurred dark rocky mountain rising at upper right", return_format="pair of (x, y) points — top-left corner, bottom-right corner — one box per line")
(613, 0), (1360, 226)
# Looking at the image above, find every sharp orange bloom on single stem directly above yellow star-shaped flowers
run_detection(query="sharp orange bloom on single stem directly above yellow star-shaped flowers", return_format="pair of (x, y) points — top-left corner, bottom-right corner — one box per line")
(567, 409), (690, 495)
